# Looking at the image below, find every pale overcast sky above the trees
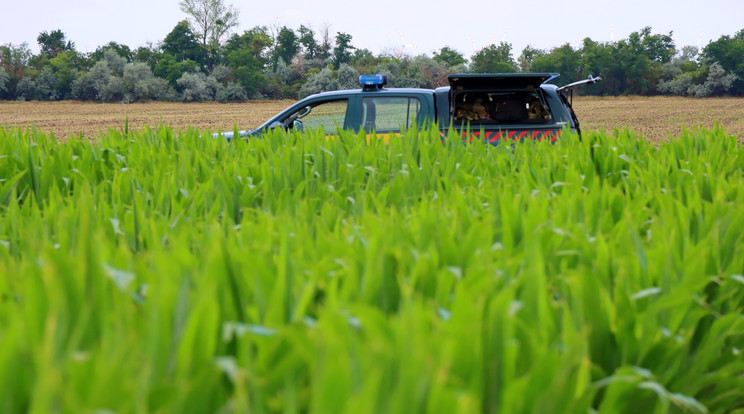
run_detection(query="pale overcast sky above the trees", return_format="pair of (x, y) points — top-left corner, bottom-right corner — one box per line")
(0, 0), (744, 58)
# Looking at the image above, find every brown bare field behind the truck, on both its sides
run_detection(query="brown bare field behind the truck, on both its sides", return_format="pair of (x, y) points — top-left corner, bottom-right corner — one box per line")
(0, 96), (744, 142)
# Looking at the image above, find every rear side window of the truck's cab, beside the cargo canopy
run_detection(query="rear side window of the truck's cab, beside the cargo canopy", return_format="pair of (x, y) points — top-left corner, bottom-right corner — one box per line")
(361, 96), (421, 132)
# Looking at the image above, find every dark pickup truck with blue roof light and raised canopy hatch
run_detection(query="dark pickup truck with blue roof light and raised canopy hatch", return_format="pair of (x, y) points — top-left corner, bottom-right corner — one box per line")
(220, 73), (601, 145)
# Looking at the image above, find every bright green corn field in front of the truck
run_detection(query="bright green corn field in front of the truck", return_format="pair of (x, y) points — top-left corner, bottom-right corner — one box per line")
(0, 127), (744, 414)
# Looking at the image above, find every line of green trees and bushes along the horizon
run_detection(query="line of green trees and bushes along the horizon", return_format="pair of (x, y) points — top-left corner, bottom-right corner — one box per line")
(0, 0), (744, 102)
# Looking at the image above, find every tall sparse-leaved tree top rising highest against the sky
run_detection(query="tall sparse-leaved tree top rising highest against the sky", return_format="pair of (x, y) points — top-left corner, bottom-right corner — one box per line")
(178, 0), (238, 49)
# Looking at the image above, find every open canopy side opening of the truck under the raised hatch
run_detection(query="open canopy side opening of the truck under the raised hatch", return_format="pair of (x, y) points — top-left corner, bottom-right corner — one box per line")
(453, 91), (552, 125)
